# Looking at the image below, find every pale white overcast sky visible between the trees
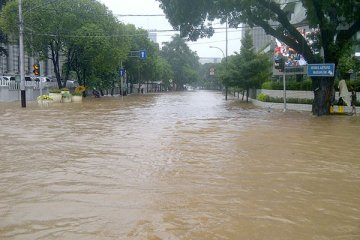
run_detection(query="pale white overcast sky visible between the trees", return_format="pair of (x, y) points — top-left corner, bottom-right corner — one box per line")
(98, 0), (241, 58)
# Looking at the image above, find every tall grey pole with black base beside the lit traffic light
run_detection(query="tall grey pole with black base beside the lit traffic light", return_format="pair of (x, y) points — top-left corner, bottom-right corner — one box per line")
(19, 0), (26, 108)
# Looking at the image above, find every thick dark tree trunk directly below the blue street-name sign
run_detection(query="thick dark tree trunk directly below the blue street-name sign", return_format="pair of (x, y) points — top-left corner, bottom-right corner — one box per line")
(312, 77), (334, 116)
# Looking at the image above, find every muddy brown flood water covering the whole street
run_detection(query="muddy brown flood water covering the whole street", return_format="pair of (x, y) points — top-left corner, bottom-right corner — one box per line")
(0, 91), (360, 240)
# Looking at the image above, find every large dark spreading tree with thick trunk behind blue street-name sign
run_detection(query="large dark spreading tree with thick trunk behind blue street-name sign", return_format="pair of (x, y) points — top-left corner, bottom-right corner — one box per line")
(158, 0), (360, 115)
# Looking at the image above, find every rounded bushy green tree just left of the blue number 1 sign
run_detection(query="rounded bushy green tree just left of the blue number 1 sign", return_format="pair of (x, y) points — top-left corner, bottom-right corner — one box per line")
(63, 18), (130, 94)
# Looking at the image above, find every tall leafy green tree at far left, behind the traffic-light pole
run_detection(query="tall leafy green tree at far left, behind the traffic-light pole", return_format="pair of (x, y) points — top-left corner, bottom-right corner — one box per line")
(1, 0), (121, 87)
